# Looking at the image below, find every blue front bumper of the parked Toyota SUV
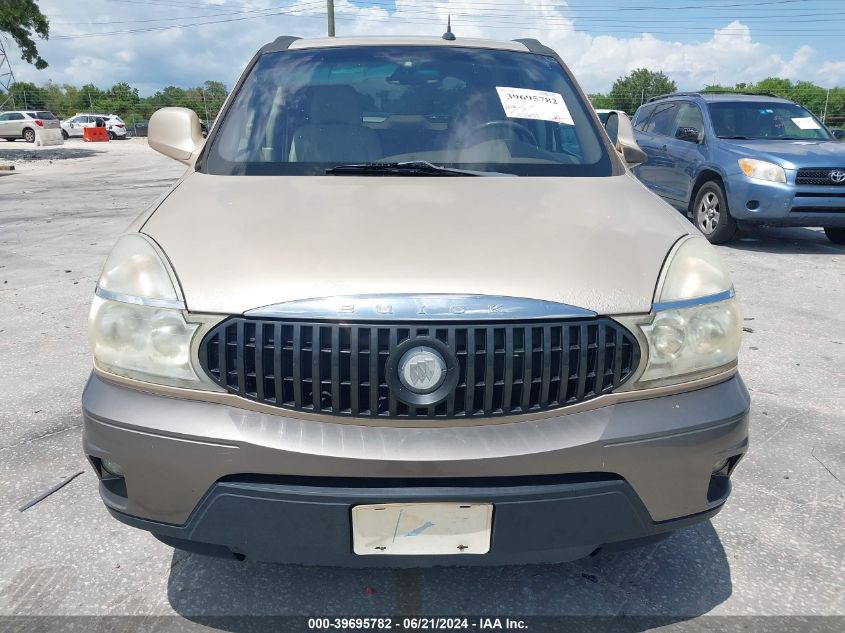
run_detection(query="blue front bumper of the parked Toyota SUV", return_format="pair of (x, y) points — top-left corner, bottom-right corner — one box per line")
(726, 170), (845, 227)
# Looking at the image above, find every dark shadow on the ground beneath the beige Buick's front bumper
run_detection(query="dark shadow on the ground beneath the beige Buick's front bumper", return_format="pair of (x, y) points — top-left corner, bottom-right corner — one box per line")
(168, 521), (732, 633)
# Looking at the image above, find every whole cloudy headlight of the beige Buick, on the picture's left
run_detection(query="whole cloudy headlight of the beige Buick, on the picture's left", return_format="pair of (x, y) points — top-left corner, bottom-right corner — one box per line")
(89, 234), (200, 388)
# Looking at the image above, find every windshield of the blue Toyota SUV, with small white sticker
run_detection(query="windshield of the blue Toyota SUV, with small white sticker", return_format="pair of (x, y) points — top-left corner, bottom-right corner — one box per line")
(709, 101), (831, 141)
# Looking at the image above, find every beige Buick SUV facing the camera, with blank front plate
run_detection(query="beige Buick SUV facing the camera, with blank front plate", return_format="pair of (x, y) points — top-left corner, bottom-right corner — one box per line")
(82, 37), (749, 566)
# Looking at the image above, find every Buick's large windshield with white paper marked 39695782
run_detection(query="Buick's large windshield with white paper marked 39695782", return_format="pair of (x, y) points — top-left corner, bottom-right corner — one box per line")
(205, 46), (613, 176)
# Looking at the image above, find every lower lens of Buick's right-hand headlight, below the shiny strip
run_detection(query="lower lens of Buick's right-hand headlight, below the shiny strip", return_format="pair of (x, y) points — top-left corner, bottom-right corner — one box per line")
(640, 298), (742, 382)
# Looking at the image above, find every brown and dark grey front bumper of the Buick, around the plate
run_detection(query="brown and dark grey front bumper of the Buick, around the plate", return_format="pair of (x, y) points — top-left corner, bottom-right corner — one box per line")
(83, 376), (749, 566)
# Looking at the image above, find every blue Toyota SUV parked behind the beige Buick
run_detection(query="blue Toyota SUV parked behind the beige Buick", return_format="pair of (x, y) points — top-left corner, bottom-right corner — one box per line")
(633, 93), (845, 244)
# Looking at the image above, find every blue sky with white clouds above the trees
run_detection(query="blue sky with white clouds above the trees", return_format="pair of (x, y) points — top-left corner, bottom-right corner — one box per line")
(6, 0), (845, 96)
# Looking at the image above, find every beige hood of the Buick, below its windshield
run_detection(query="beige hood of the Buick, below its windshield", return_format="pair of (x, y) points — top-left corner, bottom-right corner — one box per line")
(142, 172), (692, 314)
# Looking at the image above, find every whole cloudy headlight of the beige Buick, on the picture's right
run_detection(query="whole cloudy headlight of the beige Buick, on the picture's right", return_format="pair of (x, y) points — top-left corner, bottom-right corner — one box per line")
(638, 236), (742, 383)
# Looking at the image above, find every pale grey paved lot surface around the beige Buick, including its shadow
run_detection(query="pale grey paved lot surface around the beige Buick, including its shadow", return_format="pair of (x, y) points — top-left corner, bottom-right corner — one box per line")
(0, 140), (845, 631)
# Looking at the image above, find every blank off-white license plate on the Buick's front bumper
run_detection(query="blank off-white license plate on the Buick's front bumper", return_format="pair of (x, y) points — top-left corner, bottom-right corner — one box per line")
(352, 503), (493, 556)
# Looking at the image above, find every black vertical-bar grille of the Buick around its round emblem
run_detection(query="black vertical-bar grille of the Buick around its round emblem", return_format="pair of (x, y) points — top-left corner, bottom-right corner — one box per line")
(200, 317), (640, 418)
